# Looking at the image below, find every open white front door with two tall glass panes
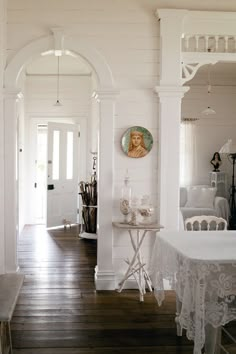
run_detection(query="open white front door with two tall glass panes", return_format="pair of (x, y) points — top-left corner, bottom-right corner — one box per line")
(47, 123), (78, 227)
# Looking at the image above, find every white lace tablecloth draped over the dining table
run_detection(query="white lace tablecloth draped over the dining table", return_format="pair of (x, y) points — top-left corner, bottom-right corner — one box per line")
(150, 231), (236, 354)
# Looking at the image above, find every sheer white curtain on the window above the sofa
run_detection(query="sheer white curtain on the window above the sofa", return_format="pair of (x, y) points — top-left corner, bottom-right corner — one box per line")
(180, 118), (197, 186)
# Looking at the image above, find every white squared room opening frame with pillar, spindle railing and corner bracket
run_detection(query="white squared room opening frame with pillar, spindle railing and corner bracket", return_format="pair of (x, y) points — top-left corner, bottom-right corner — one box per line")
(155, 9), (236, 230)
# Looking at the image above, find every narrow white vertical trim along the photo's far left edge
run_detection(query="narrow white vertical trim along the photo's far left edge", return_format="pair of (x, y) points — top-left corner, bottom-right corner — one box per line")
(0, 0), (7, 274)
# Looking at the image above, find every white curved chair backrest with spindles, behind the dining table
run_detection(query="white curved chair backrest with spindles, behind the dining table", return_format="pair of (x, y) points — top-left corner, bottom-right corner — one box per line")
(184, 215), (227, 231)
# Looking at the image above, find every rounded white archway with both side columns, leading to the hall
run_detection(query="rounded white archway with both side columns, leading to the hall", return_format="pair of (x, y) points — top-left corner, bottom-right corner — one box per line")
(4, 33), (117, 289)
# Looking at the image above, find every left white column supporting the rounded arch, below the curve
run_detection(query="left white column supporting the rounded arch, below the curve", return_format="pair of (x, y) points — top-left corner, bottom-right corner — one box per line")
(4, 90), (21, 273)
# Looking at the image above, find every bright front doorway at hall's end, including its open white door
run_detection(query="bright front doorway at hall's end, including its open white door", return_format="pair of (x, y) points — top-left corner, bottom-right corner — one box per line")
(30, 119), (81, 227)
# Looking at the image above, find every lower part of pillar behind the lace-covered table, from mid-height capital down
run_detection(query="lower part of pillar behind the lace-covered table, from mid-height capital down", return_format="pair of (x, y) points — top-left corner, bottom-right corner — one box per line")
(155, 86), (189, 230)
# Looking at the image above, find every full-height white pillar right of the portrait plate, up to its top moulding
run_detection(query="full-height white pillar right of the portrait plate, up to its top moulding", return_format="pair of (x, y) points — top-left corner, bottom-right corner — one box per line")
(155, 9), (189, 230)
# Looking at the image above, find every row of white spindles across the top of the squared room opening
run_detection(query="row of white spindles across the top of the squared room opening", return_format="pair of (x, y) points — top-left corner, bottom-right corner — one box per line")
(182, 34), (236, 53)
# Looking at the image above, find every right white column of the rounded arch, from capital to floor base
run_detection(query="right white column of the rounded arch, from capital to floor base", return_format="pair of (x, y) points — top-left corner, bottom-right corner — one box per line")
(92, 91), (117, 290)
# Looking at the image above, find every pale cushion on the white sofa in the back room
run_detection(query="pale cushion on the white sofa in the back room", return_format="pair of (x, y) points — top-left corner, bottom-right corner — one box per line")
(185, 186), (216, 209)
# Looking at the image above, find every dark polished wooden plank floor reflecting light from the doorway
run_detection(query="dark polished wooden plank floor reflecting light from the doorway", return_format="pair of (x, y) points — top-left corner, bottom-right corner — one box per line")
(11, 226), (236, 354)
